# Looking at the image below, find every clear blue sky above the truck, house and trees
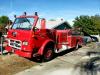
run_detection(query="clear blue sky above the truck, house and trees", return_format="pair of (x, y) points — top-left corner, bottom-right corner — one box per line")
(0, 0), (100, 24)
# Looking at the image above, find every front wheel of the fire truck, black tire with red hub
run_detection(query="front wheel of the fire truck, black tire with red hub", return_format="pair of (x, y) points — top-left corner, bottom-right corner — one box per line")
(43, 48), (54, 62)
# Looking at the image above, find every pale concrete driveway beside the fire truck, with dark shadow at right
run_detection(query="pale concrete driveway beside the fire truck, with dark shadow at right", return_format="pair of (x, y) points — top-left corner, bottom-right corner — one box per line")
(15, 43), (100, 75)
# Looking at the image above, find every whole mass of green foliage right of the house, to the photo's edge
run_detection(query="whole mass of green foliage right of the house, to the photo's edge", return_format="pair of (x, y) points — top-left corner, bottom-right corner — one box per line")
(73, 15), (100, 34)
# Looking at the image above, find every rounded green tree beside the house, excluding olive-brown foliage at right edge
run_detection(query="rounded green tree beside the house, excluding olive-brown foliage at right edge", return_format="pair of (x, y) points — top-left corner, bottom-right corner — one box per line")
(73, 15), (97, 34)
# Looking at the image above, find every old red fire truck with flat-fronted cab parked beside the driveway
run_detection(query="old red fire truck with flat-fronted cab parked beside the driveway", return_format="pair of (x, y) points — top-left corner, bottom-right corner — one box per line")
(6, 12), (82, 61)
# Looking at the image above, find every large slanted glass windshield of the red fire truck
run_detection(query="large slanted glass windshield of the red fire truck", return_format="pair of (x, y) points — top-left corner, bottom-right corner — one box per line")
(12, 18), (34, 30)
